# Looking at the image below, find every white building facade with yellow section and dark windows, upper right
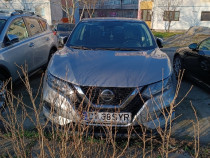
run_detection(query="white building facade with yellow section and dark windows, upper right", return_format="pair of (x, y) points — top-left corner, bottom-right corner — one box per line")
(138, 0), (210, 31)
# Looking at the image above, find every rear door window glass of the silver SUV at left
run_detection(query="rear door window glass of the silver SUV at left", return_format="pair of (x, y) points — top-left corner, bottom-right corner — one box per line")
(25, 18), (42, 36)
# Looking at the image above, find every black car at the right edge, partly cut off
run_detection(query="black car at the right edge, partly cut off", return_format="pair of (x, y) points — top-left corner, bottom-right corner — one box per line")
(173, 38), (210, 90)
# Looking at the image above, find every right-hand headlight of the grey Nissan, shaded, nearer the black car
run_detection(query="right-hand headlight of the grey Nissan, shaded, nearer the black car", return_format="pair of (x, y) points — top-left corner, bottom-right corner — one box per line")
(143, 77), (171, 98)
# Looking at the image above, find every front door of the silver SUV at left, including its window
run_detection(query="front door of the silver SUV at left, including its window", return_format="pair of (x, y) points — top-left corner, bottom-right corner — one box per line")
(1, 18), (32, 79)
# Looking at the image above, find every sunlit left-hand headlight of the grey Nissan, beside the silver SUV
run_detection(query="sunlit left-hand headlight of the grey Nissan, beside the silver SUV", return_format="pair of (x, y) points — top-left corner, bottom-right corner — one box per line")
(47, 72), (74, 95)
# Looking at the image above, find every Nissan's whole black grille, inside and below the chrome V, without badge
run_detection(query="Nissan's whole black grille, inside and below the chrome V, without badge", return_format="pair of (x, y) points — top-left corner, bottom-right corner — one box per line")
(74, 86), (147, 120)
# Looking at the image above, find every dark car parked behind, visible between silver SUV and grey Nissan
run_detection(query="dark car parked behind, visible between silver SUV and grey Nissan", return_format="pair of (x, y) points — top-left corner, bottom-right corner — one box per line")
(54, 23), (75, 47)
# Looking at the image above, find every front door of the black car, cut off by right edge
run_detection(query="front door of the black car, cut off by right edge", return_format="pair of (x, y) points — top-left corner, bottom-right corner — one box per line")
(198, 38), (210, 85)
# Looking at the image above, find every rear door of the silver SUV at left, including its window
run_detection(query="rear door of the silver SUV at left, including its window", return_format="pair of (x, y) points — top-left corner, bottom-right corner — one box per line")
(24, 17), (50, 70)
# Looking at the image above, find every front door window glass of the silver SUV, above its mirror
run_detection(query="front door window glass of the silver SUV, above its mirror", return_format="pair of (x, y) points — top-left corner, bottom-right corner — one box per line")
(7, 18), (28, 41)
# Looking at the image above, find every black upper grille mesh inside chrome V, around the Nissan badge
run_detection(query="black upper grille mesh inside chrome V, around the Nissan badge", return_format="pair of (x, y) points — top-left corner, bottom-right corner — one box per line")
(80, 86), (135, 105)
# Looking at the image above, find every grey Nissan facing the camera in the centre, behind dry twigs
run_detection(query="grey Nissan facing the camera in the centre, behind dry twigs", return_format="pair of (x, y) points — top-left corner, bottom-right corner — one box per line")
(43, 18), (175, 135)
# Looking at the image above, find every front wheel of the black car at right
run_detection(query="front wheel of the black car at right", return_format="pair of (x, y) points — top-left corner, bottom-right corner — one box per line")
(173, 55), (184, 79)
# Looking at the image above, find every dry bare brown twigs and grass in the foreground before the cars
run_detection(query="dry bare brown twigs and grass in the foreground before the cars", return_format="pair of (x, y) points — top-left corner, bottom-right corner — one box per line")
(0, 68), (203, 158)
